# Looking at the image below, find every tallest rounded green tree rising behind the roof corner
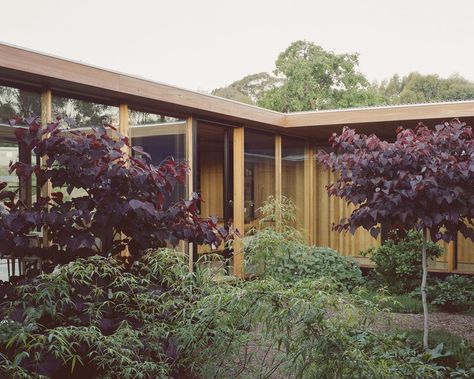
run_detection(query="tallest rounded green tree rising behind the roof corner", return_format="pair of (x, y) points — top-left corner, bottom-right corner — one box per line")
(257, 41), (378, 112)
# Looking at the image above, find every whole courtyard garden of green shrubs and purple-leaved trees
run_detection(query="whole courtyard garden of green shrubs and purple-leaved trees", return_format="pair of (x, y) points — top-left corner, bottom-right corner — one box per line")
(0, 119), (474, 378)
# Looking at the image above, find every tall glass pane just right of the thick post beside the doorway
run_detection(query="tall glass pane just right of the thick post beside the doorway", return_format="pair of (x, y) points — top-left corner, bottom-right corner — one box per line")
(244, 129), (275, 230)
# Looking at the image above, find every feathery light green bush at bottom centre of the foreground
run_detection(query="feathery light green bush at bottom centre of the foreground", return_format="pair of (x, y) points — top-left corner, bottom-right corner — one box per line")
(179, 278), (442, 378)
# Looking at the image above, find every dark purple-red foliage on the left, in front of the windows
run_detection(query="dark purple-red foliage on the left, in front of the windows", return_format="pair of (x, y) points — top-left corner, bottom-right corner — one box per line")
(0, 119), (226, 263)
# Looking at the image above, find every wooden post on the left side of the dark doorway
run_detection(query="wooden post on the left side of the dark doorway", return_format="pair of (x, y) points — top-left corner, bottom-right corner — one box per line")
(184, 117), (197, 272)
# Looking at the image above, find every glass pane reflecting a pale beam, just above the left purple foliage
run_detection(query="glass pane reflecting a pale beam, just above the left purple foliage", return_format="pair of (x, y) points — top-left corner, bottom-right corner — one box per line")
(129, 111), (186, 203)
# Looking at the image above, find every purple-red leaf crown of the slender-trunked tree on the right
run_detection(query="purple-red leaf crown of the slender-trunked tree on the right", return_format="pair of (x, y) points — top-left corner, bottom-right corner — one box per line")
(317, 119), (474, 241)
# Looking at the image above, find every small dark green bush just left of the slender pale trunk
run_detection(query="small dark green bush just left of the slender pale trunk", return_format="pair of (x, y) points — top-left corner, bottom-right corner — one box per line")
(365, 231), (442, 294)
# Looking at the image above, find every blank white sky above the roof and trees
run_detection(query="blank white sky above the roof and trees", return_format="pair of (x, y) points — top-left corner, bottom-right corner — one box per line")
(0, 0), (474, 91)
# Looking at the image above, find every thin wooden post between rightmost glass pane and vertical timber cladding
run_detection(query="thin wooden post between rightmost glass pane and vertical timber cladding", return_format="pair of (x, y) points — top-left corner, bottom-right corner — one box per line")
(304, 144), (315, 245)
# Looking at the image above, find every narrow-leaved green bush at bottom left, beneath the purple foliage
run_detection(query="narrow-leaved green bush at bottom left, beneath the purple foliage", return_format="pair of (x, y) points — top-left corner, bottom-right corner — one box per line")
(0, 250), (197, 378)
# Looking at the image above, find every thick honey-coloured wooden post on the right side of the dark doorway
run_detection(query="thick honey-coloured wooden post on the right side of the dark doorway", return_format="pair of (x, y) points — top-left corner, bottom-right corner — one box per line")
(234, 127), (245, 278)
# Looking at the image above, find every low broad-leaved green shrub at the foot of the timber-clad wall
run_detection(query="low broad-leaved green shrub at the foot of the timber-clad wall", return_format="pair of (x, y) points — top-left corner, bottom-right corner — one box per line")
(245, 228), (363, 289)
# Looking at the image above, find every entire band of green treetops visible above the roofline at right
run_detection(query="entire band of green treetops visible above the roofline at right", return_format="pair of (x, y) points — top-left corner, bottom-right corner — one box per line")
(212, 41), (474, 112)
